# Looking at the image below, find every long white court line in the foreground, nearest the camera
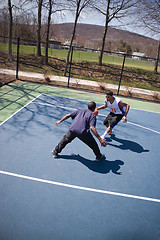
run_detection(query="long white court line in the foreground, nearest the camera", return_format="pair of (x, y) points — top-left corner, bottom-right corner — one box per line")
(0, 170), (160, 203)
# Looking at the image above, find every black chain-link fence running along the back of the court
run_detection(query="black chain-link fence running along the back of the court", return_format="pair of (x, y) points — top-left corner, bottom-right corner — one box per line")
(0, 36), (160, 94)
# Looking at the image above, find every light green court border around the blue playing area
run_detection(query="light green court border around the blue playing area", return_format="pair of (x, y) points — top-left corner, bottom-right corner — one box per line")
(0, 81), (160, 123)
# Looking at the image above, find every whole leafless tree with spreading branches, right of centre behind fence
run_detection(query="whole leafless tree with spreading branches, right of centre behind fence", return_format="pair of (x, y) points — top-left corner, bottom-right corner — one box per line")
(92, 0), (137, 66)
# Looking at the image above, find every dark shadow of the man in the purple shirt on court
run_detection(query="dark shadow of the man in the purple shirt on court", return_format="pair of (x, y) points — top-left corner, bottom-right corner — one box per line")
(60, 154), (124, 175)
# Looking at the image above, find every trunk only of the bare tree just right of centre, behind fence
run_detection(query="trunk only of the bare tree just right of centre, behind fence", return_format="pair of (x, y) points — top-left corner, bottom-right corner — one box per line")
(98, 0), (110, 66)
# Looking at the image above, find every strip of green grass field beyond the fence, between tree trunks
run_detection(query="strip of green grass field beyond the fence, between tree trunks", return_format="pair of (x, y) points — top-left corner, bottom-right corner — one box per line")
(0, 43), (160, 72)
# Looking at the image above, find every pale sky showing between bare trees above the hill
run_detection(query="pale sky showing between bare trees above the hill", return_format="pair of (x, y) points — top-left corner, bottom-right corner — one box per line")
(0, 0), (160, 40)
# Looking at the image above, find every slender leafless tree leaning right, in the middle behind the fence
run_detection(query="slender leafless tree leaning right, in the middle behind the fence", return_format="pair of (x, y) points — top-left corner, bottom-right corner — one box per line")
(64, 0), (91, 76)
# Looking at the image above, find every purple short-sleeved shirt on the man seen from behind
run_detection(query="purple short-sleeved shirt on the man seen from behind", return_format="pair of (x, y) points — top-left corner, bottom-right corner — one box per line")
(69, 109), (96, 134)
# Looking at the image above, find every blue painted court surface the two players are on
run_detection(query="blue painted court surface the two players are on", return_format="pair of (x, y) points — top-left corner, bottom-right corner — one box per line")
(0, 94), (160, 240)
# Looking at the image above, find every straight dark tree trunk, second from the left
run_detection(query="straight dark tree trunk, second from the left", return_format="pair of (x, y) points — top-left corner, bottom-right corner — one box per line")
(37, 0), (43, 56)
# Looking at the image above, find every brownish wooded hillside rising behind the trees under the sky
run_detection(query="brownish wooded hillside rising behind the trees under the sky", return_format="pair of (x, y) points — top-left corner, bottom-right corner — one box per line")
(51, 23), (158, 58)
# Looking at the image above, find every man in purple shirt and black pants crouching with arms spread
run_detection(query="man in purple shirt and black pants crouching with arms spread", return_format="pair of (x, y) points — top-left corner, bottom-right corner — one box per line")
(52, 102), (107, 161)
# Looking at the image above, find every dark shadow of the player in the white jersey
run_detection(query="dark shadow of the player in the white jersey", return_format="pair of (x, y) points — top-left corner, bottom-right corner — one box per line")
(106, 134), (149, 153)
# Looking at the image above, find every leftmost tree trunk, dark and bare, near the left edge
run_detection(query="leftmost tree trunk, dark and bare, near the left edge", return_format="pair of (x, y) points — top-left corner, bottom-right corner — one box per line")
(8, 0), (13, 61)
